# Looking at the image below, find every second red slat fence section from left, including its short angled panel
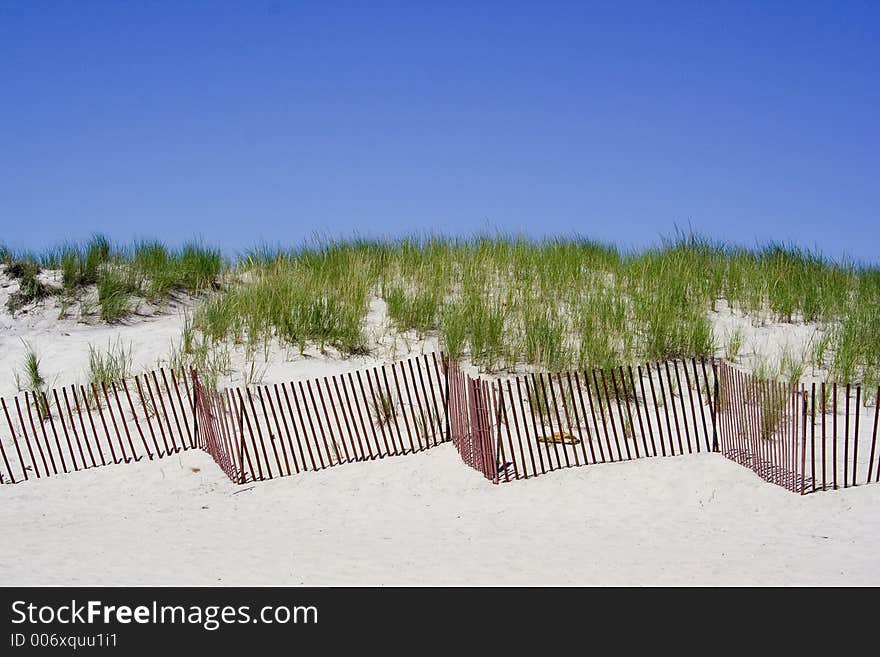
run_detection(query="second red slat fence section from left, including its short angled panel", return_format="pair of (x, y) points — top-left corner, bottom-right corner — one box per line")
(199, 354), (447, 483)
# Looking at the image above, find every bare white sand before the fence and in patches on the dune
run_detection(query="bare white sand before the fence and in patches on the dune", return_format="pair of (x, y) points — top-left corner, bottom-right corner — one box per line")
(0, 272), (880, 585)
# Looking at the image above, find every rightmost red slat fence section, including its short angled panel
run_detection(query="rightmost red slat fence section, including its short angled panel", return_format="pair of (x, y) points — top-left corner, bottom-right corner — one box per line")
(718, 363), (880, 495)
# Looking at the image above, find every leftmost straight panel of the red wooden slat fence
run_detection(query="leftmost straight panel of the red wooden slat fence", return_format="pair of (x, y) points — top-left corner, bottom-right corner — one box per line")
(0, 369), (196, 483)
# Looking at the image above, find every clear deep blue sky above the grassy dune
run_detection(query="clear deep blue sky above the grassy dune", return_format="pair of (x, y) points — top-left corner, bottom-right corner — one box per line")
(0, 0), (880, 262)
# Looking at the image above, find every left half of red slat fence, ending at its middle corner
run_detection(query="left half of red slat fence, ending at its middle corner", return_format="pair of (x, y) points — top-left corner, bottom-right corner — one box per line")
(0, 354), (448, 483)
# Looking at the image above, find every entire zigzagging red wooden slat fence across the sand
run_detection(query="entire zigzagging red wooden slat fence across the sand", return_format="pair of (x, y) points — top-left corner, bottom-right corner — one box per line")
(0, 354), (880, 494)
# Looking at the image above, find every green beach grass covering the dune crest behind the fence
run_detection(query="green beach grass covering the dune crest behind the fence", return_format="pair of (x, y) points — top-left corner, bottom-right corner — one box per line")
(0, 233), (880, 386)
